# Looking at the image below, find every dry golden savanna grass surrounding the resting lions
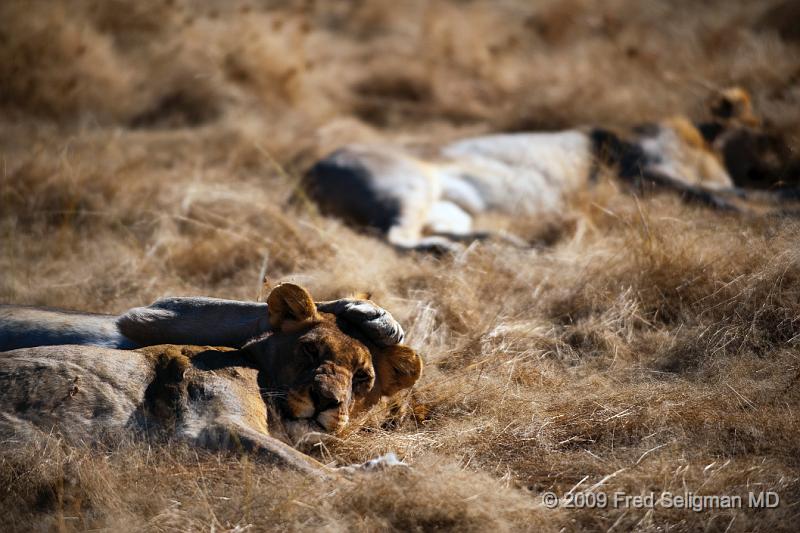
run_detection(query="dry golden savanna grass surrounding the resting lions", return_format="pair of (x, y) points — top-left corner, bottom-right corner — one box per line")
(0, 0), (800, 531)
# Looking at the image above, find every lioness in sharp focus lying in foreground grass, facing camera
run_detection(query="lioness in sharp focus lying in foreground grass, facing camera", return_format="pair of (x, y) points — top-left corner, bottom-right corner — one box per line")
(0, 284), (422, 473)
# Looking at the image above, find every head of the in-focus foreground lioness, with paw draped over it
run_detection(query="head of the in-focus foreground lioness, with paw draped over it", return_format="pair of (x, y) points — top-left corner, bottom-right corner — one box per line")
(245, 283), (422, 432)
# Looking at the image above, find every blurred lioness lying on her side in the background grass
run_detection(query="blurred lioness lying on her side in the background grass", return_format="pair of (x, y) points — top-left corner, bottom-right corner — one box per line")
(305, 88), (788, 249)
